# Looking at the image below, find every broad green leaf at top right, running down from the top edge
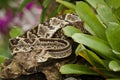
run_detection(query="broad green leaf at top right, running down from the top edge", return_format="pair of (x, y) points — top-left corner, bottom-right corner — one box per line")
(87, 0), (119, 27)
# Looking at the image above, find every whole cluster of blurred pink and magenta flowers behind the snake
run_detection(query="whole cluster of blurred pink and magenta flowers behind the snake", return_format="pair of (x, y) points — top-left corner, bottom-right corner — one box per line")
(0, 0), (42, 34)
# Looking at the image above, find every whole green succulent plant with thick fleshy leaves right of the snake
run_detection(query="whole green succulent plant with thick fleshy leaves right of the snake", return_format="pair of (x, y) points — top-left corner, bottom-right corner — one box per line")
(57, 0), (120, 80)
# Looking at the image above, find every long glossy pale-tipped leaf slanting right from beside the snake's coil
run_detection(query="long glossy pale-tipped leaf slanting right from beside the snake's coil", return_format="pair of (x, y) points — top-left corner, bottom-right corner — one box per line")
(72, 33), (117, 60)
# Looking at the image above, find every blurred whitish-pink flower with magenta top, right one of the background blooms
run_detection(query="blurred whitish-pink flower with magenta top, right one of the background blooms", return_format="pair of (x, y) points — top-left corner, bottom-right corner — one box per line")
(11, 2), (42, 31)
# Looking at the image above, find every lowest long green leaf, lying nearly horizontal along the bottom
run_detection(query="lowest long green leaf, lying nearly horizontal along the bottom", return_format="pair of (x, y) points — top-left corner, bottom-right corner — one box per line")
(60, 64), (119, 78)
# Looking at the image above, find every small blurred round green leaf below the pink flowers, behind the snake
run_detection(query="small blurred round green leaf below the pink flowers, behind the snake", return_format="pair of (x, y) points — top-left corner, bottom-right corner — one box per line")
(9, 27), (24, 38)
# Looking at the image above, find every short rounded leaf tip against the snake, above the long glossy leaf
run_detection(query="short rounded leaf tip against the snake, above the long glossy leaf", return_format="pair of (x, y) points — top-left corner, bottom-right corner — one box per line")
(63, 26), (81, 37)
